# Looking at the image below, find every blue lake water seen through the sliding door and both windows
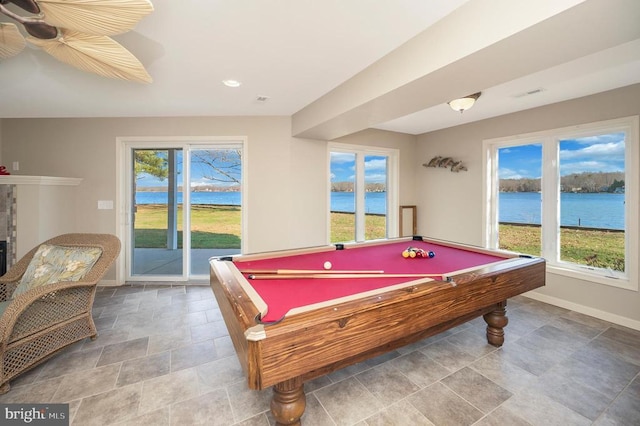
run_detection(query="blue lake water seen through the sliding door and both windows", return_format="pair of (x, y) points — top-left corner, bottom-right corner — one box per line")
(136, 192), (624, 229)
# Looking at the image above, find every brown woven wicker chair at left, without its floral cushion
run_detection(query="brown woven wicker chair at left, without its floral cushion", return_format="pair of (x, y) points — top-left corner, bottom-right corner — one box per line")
(0, 234), (120, 394)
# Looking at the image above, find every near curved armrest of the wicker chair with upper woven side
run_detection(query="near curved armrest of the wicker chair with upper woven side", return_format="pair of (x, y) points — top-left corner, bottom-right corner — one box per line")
(0, 281), (96, 348)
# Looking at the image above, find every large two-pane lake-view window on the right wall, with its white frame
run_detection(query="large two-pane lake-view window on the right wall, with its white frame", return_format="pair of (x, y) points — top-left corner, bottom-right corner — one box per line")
(484, 117), (638, 289)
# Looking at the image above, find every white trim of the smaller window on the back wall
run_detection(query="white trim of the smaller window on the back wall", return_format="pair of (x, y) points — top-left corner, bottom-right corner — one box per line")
(327, 142), (400, 242)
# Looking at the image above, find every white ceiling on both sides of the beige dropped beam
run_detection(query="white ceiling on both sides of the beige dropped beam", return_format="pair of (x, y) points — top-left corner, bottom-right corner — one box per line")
(0, 0), (640, 134)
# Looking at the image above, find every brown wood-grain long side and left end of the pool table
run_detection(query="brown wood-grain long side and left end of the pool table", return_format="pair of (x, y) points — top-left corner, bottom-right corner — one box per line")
(211, 258), (545, 389)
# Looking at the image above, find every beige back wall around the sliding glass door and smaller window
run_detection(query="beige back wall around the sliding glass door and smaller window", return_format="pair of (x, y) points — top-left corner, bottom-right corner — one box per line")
(1, 117), (415, 279)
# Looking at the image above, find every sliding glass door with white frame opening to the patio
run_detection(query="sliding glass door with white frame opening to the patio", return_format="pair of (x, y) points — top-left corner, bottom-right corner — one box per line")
(127, 142), (243, 281)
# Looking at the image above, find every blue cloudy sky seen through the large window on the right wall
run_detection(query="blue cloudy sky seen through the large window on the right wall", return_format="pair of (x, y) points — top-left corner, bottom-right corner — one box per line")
(498, 133), (624, 179)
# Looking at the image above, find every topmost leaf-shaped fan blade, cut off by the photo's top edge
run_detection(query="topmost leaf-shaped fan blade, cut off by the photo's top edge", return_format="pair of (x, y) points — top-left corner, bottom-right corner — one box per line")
(38, 0), (153, 35)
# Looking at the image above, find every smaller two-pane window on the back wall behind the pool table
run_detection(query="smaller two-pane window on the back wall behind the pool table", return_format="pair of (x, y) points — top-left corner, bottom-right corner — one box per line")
(329, 144), (398, 243)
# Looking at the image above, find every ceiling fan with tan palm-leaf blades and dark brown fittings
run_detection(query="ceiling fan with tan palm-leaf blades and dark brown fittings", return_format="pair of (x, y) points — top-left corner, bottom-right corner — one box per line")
(0, 0), (153, 83)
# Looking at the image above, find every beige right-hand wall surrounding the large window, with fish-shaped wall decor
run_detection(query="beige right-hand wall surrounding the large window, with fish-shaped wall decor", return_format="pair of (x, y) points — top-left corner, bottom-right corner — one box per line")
(414, 85), (640, 329)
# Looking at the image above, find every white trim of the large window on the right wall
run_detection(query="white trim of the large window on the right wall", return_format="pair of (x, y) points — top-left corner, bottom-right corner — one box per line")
(482, 116), (640, 291)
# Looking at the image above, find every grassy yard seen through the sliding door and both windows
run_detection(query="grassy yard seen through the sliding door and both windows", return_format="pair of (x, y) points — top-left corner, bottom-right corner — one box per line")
(135, 204), (624, 271)
